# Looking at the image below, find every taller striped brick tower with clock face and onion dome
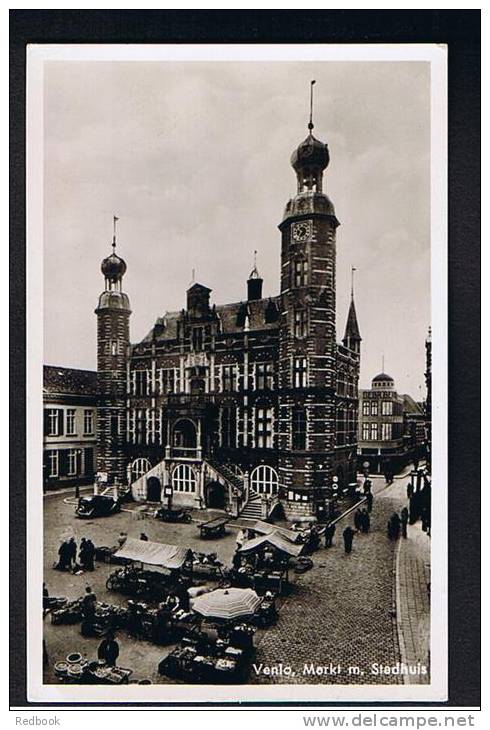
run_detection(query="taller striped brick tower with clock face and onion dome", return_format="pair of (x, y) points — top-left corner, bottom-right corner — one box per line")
(279, 86), (339, 515)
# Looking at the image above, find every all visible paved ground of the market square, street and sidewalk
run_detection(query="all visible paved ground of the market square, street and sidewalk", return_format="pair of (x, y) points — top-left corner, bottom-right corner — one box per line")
(44, 470), (428, 684)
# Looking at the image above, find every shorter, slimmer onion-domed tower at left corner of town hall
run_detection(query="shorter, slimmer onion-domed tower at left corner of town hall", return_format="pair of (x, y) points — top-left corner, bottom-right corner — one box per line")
(95, 216), (131, 485)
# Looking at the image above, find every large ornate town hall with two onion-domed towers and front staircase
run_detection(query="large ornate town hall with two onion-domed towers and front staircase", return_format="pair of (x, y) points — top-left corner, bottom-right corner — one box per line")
(95, 105), (361, 518)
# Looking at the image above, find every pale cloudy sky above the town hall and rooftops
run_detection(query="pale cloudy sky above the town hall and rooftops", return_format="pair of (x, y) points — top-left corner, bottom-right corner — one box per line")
(44, 61), (430, 400)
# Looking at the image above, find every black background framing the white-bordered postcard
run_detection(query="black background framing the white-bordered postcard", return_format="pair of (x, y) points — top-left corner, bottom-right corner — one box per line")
(10, 10), (480, 709)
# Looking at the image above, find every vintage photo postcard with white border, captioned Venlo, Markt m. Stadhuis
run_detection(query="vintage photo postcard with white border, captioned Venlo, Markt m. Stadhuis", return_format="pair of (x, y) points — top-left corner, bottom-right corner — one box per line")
(27, 44), (447, 703)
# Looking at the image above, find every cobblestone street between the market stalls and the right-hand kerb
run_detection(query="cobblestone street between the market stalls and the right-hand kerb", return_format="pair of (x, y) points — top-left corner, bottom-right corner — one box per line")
(250, 480), (406, 684)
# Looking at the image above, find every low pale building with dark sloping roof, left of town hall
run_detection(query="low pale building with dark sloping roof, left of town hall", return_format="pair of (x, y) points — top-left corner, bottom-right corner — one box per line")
(43, 365), (97, 490)
